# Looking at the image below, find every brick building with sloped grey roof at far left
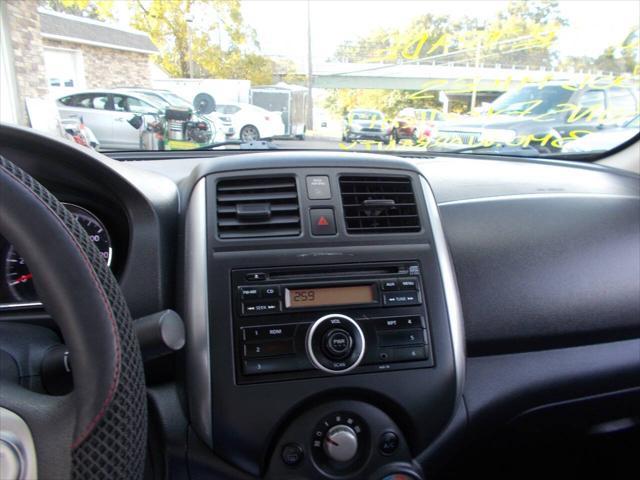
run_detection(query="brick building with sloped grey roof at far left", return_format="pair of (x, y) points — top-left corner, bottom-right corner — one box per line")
(0, 0), (158, 124)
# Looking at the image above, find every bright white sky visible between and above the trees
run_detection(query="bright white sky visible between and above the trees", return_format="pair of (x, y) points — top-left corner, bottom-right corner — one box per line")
(242, 0), (640, 62)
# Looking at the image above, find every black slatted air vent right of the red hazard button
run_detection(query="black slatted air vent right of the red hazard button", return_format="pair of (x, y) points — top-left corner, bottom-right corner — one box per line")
(340, 176), (420, 234)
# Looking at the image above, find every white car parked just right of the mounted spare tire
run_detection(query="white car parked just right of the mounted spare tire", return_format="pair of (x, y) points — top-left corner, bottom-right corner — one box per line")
(216, 103), (284, 142)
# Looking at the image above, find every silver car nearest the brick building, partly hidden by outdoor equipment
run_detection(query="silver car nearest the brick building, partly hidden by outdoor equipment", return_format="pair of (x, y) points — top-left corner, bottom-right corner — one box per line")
(57, 90), (163, 150)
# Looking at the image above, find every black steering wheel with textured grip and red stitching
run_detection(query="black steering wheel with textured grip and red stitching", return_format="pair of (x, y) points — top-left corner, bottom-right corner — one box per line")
(0, 156), (147, 480)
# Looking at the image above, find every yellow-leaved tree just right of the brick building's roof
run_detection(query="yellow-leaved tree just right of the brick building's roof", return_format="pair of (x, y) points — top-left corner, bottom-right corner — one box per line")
(132, 0), (274, 84)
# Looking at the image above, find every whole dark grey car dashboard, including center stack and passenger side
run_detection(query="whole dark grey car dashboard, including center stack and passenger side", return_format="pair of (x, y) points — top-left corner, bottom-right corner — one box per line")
(0, 125), (640, 479)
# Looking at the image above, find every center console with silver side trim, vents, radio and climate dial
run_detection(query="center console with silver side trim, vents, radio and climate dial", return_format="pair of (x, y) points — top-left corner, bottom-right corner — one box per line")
(184, 152), (464, 479)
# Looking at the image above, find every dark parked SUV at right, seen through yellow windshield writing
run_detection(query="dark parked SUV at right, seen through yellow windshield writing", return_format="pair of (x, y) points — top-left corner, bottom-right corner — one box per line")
(433, 81), (638, 152)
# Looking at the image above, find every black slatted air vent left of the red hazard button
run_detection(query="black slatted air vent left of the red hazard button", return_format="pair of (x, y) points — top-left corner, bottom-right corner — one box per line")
(216, 177), (300, 238)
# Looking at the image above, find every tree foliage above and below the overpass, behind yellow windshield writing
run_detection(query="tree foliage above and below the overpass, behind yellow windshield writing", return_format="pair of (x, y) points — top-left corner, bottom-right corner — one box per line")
(326, 1), (567, 116)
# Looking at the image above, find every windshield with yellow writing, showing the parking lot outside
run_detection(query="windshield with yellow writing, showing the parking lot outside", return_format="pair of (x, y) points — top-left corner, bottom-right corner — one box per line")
(0, 0), (640, 160)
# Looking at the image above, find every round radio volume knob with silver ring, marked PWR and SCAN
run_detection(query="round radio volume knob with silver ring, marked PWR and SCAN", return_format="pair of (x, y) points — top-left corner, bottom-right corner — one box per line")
(306, 313), (365, 373)
